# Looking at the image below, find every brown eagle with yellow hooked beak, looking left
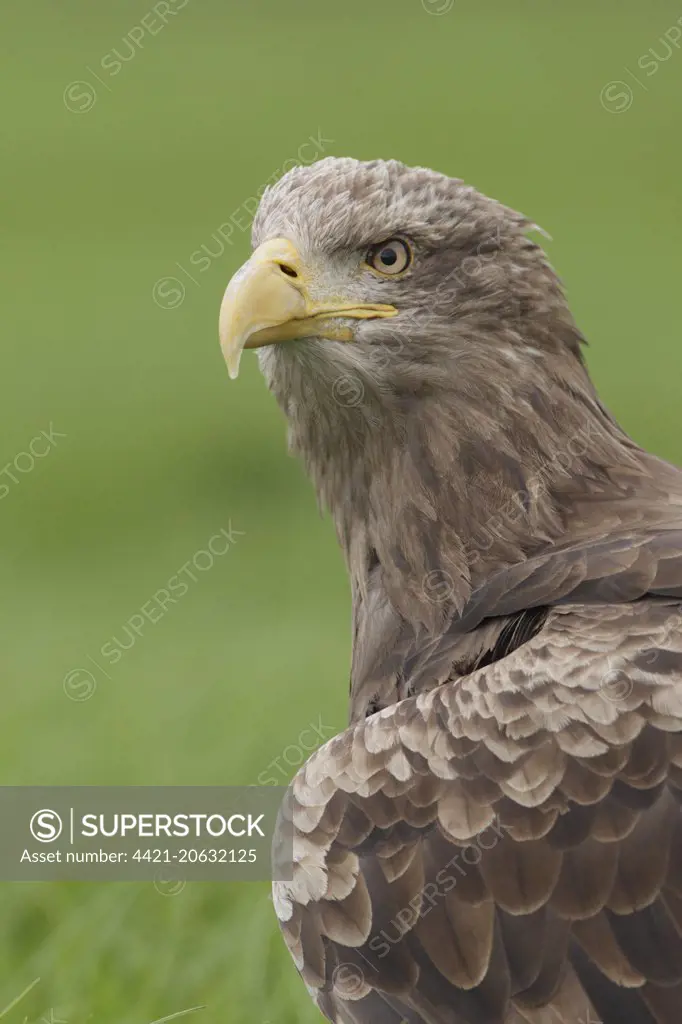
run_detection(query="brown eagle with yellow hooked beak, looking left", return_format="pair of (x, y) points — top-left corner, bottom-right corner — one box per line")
(219, 158), (682, 1024)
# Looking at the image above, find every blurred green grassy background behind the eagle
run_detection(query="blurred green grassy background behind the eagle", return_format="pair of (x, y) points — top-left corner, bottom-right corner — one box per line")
(0, 0), (682, 1024)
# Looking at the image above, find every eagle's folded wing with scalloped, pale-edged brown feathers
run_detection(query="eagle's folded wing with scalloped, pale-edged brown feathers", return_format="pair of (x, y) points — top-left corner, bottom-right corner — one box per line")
(274, 598), (682, 1024)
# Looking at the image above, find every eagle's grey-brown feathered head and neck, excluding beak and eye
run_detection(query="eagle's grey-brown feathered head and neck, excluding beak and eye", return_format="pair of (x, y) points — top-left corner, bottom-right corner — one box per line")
(248, 158), (681, 631)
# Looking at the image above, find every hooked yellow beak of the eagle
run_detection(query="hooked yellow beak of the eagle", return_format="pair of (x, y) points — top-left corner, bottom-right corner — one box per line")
(219, 239), (397, 379)
